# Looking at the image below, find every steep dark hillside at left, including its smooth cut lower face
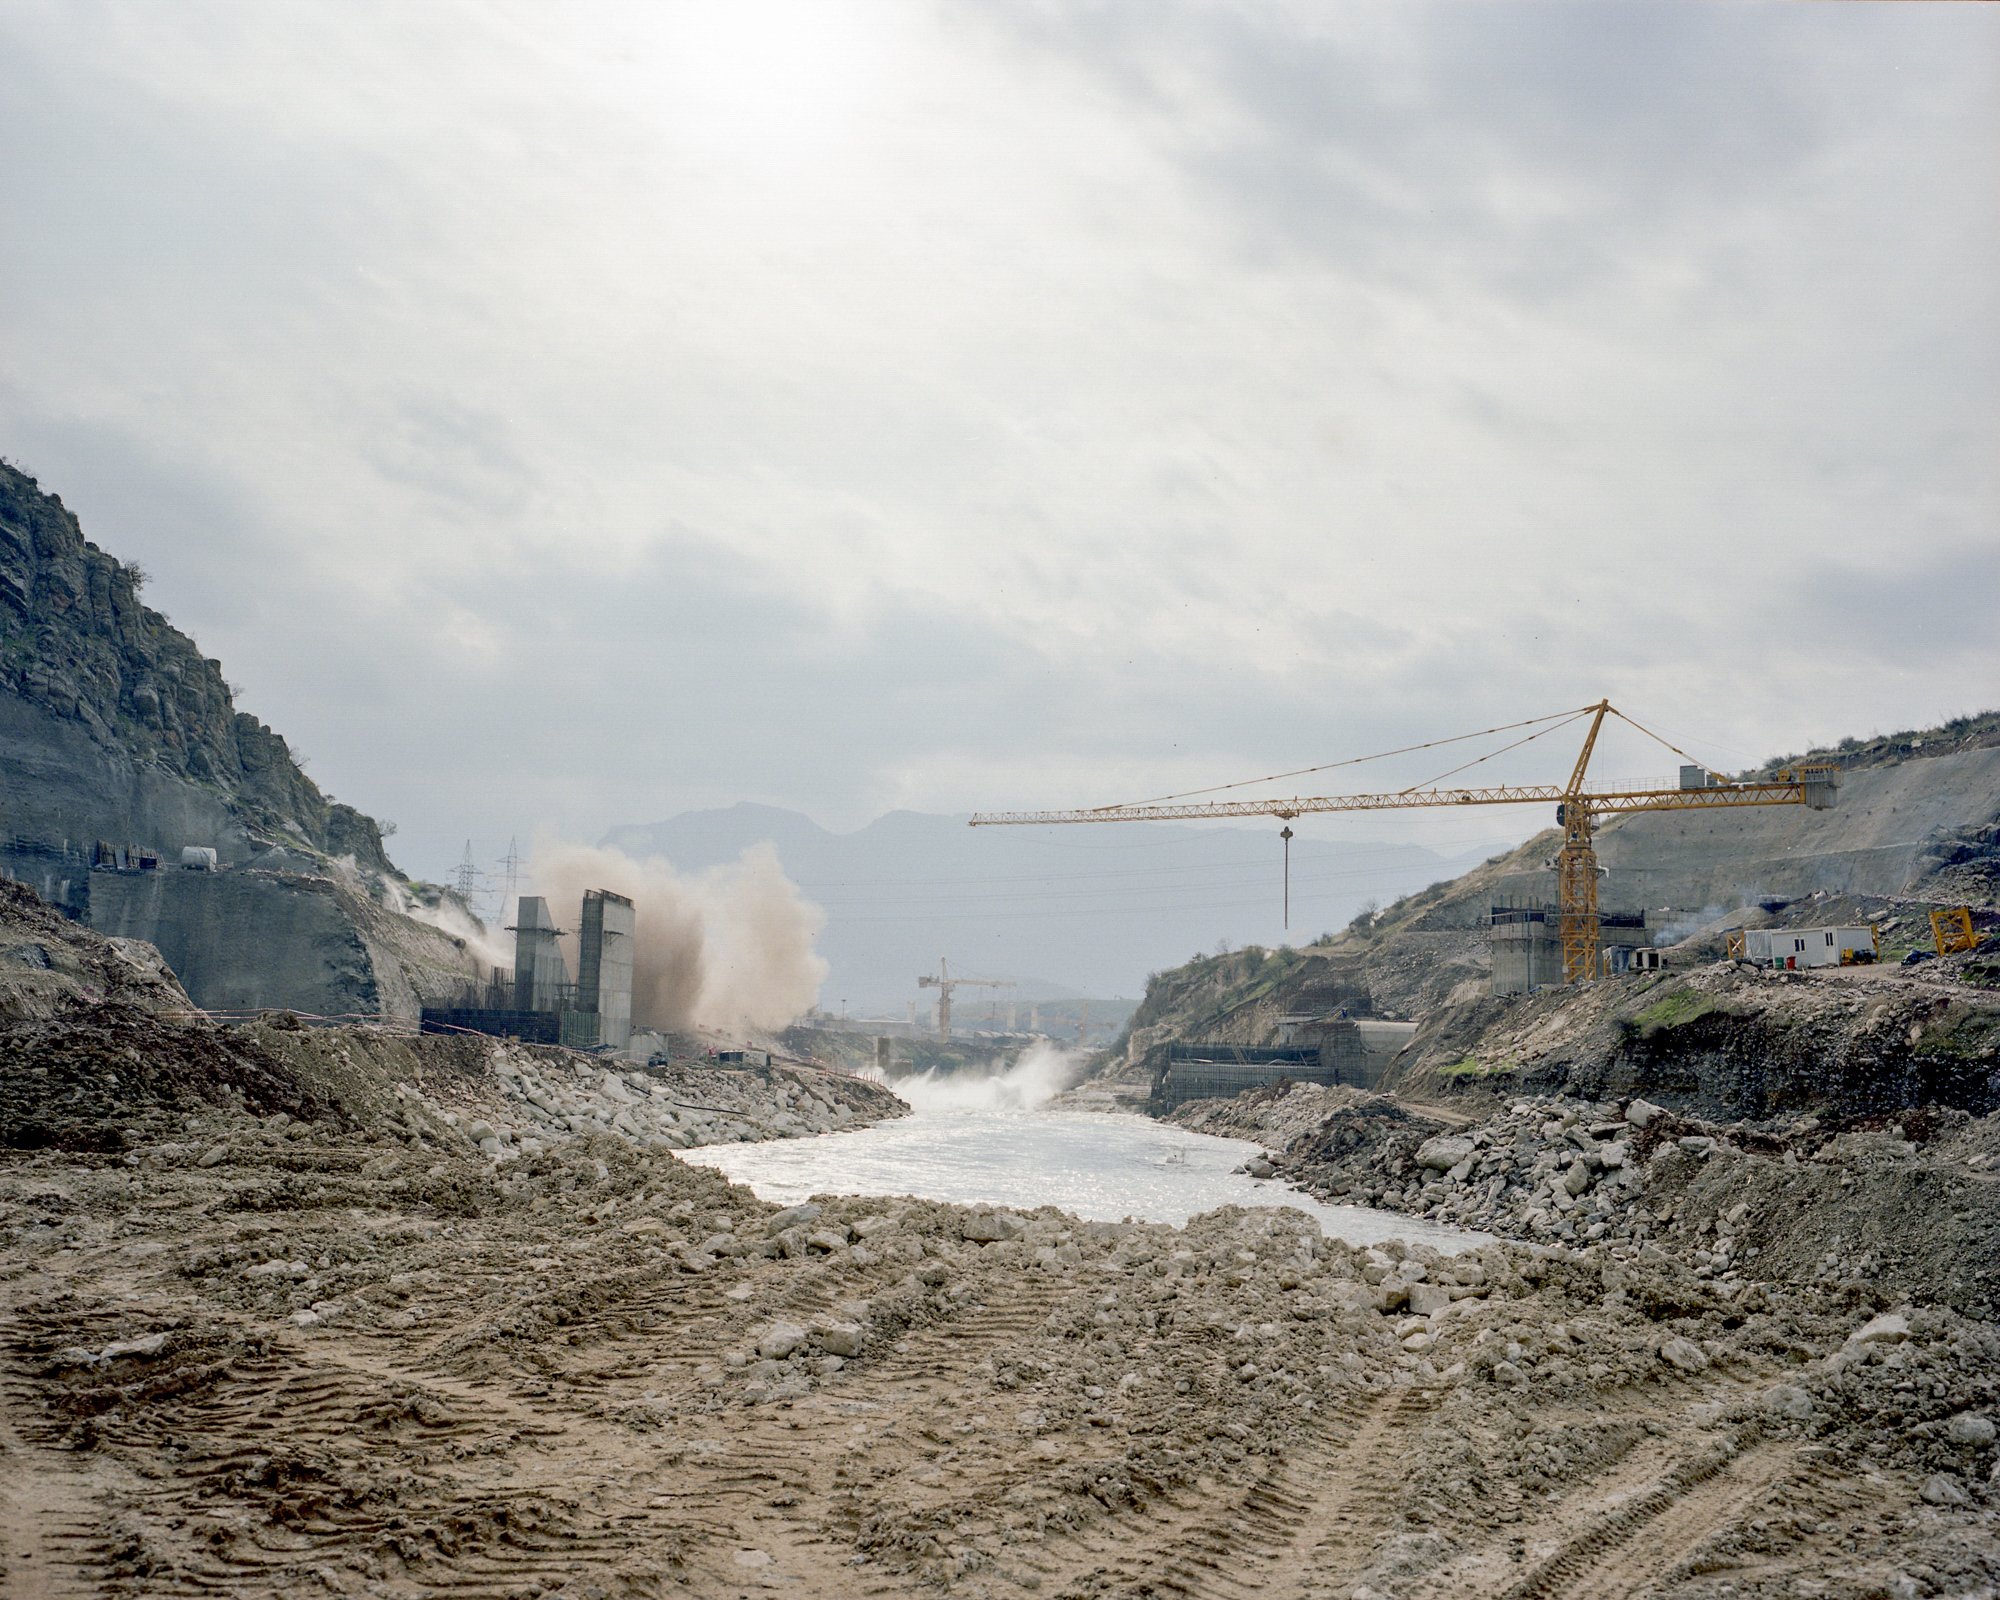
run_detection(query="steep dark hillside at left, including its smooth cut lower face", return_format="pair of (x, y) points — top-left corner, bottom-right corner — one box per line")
(0, 462), (478, 1018)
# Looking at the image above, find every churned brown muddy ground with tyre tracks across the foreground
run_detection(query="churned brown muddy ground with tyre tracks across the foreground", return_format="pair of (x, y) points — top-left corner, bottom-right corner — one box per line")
(0, 888), (2000, 1600)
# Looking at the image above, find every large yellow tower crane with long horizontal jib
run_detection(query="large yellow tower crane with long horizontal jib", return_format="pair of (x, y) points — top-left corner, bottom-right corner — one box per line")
(972, 700), (1834, 984)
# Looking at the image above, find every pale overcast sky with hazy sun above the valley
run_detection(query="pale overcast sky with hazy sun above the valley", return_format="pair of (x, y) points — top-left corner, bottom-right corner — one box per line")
(0, 0), (2000, 876)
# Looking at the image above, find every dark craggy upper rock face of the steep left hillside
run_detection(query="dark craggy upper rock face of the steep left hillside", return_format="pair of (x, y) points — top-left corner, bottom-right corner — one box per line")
(0, 462), (394, 872)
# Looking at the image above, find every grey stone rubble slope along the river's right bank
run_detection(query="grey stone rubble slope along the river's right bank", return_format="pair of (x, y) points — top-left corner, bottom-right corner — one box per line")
(1172, 1082), (2000, 1318)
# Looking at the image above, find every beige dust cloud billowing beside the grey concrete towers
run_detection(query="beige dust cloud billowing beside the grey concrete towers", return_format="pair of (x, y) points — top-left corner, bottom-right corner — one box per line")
(528, 844), (826, 1032)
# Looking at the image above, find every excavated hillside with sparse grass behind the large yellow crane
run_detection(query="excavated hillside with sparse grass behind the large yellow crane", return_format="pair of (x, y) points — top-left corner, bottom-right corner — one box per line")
(1112, 712), (2000, 1060)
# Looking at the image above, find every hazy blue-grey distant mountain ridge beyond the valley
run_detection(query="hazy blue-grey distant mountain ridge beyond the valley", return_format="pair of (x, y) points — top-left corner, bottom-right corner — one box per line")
(602, 802), (1490, 1014)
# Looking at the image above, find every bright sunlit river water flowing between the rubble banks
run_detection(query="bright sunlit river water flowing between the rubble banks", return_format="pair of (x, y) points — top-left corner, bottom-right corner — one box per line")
(682, 1052), (1486, 1250)
